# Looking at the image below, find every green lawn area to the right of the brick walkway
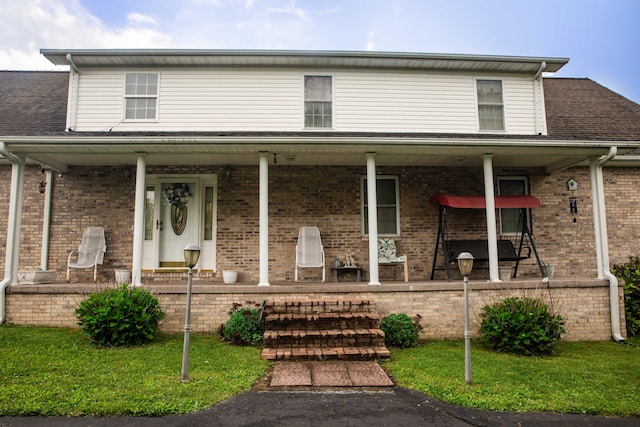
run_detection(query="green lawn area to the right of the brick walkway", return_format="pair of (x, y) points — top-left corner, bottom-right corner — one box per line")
(384, 341), (640, 417)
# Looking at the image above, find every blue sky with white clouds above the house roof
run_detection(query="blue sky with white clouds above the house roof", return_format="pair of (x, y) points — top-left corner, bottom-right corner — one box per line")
(0, 0), (640, 103)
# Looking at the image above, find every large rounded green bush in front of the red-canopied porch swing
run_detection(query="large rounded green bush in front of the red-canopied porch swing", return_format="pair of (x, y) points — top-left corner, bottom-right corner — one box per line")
(480, 297), (566, 356)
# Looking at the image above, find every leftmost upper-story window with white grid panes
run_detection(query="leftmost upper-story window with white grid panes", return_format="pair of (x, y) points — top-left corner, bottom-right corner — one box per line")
(124, 73), (158, 120)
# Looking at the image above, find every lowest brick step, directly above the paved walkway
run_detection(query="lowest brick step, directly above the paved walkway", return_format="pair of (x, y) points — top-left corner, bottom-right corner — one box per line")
(262, 346), (391, 360)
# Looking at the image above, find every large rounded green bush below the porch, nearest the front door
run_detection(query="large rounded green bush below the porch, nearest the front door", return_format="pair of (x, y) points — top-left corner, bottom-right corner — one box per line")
(76, 284), (164, 347)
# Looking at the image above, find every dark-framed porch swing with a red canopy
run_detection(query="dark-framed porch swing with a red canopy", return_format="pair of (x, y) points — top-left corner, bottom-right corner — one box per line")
(429, 194), (547, 281)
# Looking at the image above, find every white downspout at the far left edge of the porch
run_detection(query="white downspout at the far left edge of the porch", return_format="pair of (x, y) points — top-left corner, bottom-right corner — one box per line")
(0, 142), (25, 325)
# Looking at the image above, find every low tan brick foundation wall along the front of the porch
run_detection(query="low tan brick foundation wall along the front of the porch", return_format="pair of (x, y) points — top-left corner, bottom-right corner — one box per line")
(6, 280), (625, 341)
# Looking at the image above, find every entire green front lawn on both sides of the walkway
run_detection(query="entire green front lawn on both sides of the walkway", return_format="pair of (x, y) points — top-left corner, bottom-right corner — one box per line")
(0, 325), (640, 416)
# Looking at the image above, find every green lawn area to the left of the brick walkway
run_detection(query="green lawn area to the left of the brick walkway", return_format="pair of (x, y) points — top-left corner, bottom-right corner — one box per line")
(0, 325), (268, 416)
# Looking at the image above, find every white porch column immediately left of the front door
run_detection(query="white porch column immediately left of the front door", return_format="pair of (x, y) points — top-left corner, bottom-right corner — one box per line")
(131, 153), (147, 286)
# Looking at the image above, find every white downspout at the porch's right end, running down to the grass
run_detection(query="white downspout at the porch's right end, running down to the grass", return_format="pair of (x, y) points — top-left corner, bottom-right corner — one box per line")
(590, 147), (625, 342)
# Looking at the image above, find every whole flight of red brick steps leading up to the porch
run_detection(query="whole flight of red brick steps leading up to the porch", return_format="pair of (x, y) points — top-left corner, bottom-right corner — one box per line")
(262, 299), (390, 360)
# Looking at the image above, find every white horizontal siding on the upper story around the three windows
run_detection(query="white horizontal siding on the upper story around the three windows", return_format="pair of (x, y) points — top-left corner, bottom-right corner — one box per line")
(70, 68), (535, 134)
